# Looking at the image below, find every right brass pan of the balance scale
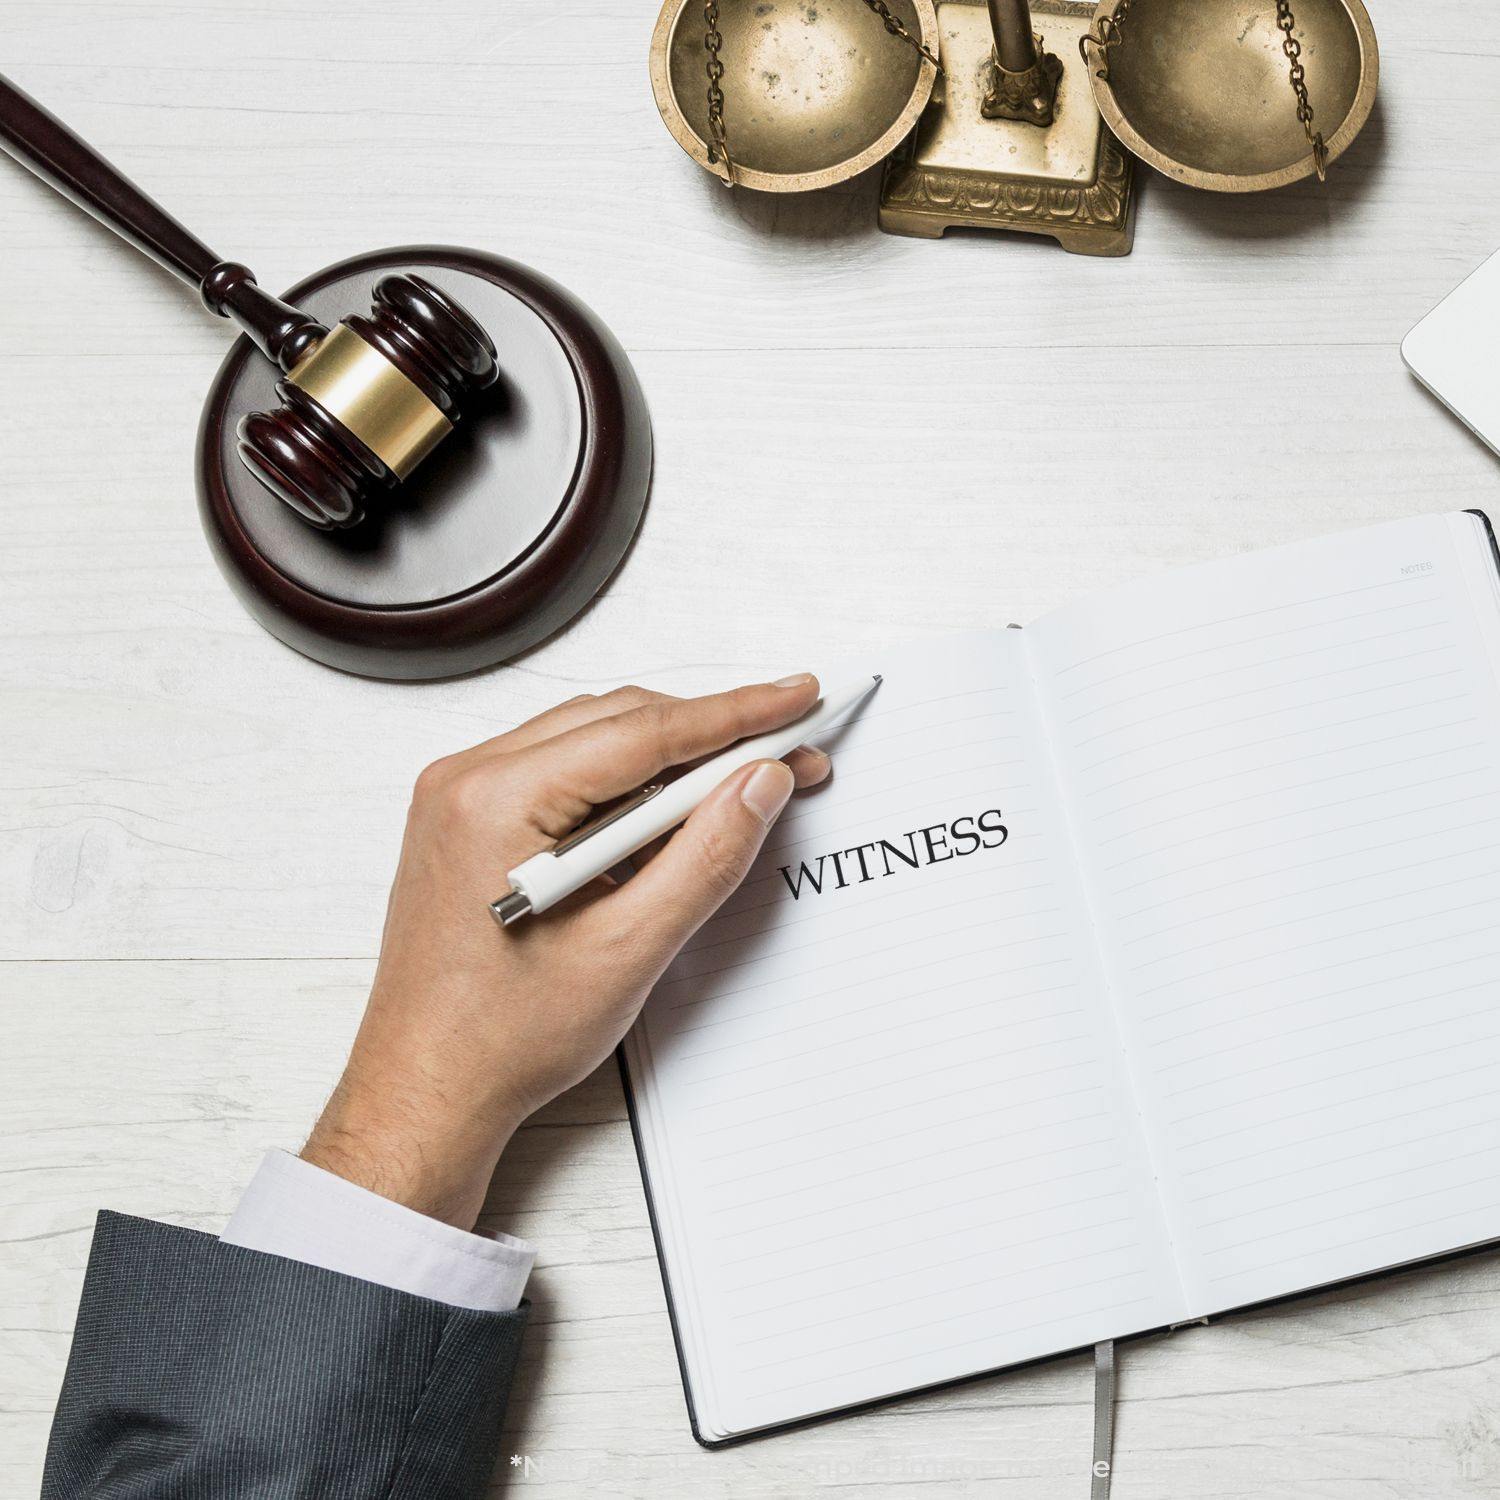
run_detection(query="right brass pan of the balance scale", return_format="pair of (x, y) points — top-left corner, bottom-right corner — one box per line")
(1088, 0), (1380, 192)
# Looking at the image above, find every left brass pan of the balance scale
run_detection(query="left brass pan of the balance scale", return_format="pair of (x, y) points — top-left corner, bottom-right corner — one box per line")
(651, 0), (938, 192)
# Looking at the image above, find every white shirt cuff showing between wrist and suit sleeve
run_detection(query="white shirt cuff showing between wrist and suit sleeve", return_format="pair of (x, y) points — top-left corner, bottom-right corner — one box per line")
(219, 1151), (537, 1313)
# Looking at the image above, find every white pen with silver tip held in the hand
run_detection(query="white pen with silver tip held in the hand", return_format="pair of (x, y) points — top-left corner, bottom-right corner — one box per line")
(489, 677), (881, 927)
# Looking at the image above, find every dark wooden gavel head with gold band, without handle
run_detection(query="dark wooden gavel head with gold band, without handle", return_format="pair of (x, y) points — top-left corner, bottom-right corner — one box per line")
(239, 275), (500, 531)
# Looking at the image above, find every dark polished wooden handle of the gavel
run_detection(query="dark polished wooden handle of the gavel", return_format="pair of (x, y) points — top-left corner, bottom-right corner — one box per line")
(0, 74), (327, 369)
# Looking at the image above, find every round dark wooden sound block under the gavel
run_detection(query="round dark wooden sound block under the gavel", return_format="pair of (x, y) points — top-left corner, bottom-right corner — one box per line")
(198, 245), (651, 678)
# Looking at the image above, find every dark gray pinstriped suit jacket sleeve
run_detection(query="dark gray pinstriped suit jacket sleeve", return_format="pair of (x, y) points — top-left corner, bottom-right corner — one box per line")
(42, 1214), (527, 1500)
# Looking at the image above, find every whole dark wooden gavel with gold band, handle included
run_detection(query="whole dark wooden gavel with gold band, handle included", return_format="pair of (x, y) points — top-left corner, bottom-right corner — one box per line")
(0, 77), (500, 531)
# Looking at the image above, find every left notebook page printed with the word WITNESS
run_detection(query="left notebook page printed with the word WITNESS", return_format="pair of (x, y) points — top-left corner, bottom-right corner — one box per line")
(627, 632), (1184, 1437)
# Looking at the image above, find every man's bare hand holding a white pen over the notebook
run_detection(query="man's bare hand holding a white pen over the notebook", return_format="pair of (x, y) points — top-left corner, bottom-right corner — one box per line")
(302, 675), (828, 1229)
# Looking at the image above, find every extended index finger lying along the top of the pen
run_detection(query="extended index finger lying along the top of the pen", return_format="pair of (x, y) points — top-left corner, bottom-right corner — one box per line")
(516, 674), (819, 837)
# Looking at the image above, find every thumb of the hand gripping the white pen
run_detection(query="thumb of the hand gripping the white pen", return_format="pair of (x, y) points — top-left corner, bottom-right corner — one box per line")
(606, 761), (795, 962)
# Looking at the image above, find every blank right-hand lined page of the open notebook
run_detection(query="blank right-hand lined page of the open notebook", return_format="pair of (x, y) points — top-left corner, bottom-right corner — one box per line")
(1026, 516), (1500, 1314)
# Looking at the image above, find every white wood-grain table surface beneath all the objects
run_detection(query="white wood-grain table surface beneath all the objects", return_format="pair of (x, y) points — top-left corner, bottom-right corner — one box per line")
(0, 0), (1500, 1500)
